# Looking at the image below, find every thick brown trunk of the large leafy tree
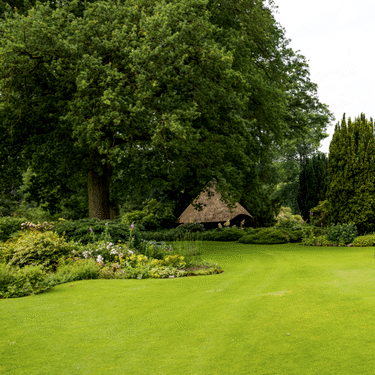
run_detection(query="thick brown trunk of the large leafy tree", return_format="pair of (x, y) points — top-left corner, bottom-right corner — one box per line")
(88, 165), (111, 220)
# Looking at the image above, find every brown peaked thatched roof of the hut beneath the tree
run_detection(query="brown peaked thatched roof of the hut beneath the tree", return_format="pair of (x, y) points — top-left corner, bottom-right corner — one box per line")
(177, 188), (252, 224)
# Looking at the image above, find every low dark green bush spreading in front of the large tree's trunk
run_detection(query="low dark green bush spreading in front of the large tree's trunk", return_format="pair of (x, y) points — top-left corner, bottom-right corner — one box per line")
(54, 219), (130, 244)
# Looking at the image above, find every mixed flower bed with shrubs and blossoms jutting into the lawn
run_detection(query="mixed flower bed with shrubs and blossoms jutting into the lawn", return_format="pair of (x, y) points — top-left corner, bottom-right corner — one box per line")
(0, 228), (223, 298)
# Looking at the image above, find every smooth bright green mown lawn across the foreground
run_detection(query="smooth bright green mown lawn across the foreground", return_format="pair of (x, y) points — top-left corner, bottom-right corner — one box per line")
(0, 242), (375, 375)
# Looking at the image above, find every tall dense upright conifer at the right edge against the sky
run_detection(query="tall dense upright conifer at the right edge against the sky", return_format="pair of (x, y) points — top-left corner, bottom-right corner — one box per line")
(327, 114), (375, 232)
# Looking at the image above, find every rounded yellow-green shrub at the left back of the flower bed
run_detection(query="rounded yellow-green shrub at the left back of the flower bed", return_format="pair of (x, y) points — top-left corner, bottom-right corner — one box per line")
(0, 231), (78, 268)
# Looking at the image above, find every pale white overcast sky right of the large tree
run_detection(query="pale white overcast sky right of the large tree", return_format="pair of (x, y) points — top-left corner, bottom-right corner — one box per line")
(275, 0), (375, 152)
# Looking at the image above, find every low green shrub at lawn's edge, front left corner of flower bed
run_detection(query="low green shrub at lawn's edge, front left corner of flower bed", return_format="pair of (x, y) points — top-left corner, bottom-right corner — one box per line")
(0, 264), (52, 298)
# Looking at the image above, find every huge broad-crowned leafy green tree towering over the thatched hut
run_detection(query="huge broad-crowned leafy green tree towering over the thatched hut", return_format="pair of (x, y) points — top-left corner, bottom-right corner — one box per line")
(0, 0), (334, 219)
